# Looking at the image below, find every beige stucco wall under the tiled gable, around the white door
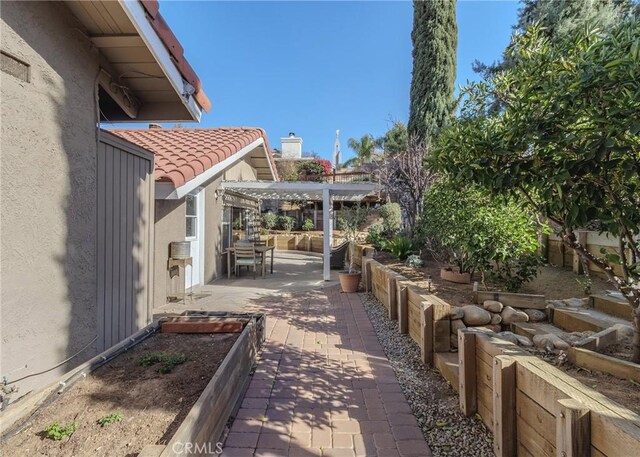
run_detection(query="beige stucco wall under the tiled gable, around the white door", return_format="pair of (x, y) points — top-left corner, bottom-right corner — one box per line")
(154, 160), (256, 307)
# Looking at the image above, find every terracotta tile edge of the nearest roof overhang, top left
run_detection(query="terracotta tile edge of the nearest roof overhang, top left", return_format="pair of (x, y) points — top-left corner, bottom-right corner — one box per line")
(140, 0), (211, 113)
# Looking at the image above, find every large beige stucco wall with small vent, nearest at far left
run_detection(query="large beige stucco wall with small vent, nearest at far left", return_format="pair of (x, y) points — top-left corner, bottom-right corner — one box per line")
(0, 2), (98, 400)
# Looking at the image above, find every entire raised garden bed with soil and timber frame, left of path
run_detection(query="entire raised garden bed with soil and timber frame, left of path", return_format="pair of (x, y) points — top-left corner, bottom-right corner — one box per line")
(2, 315), (264, 457)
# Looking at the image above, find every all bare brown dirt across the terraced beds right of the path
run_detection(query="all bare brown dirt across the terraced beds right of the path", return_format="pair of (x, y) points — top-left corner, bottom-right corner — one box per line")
(376, 252), (640, 414)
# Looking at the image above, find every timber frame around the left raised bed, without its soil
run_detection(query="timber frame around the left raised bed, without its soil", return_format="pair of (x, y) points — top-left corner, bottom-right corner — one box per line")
(1, 312), (266, 457)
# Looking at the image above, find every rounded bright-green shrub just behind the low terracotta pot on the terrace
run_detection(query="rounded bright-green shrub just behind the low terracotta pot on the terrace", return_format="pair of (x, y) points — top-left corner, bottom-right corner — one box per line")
(421, 183), (541, 291)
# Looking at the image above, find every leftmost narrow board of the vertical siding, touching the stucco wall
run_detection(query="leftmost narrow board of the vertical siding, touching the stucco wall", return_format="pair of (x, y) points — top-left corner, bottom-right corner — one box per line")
(96, 143), (106, 352)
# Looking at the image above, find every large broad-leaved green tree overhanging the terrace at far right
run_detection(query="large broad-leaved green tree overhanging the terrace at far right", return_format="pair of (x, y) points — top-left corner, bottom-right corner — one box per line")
(434, 19), (640, 362)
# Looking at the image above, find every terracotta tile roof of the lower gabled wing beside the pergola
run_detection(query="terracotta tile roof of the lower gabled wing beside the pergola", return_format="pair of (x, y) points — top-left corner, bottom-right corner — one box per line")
(109, 127), (277, 188)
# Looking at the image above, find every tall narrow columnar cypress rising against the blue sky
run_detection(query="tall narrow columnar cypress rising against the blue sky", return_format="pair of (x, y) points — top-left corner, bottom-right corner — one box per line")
(409, 0), (458, 141)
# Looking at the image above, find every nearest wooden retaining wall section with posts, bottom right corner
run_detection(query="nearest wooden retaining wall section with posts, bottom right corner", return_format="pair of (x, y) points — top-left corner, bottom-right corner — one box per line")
(458, 330), (640, 457)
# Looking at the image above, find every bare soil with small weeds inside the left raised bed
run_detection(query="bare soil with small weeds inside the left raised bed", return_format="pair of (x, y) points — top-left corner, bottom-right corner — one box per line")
(0, 333), (238, 457)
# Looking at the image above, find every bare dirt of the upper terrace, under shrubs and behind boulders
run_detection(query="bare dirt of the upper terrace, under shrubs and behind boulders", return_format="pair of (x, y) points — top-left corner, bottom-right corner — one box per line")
(376, 252), (614, 306)
